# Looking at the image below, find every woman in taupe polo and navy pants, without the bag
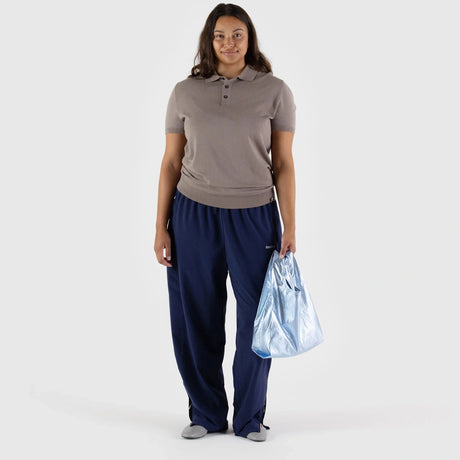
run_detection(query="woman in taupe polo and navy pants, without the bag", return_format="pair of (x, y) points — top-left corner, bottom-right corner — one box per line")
(154, 3), (296, 441)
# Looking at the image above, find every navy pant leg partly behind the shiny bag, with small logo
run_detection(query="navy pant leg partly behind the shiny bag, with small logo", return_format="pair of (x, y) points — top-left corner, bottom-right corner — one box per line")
(222, 200), (281, 436)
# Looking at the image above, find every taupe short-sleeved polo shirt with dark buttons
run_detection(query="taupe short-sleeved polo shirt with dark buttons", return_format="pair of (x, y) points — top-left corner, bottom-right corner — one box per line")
(165, 65), (296, 208)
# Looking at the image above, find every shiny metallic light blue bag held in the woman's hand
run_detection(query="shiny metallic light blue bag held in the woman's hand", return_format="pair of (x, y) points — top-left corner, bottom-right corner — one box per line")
(252, 249), (324, 358)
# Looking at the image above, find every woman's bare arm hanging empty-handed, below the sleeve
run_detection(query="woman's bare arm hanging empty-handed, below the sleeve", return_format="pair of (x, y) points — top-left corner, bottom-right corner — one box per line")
(153, 133), (187, 267)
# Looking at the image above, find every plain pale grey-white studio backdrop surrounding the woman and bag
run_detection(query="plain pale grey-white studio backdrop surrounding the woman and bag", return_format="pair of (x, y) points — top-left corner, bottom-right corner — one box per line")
(0, 0), (460, 460)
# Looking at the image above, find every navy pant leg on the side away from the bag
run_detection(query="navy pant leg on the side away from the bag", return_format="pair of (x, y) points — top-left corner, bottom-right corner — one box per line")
(167, 189), (228, 432)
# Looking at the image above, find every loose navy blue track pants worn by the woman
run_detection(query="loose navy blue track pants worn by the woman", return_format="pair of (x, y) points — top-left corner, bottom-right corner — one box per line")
(167, 189), (281, 437)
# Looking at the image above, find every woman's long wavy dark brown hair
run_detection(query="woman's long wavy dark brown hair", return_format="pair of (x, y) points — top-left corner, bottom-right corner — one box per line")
(188, 3), (272, 78)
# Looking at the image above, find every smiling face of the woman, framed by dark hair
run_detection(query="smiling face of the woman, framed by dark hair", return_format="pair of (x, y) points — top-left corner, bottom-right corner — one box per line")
(212, 16), (248, 66)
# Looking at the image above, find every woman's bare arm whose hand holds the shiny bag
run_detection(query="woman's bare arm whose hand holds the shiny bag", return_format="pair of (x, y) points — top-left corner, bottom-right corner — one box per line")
(271, 131), (296, 257)
